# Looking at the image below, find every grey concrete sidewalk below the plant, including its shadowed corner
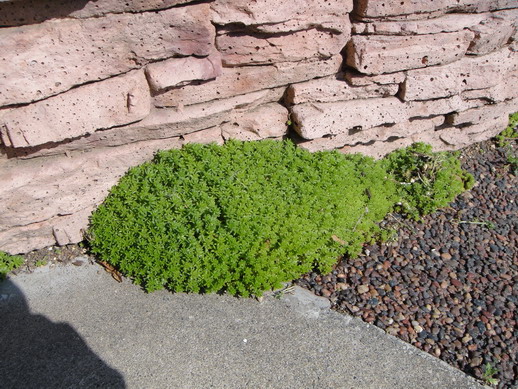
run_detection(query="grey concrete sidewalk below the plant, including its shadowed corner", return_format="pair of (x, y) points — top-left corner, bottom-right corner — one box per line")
(0, 265), (483, 389)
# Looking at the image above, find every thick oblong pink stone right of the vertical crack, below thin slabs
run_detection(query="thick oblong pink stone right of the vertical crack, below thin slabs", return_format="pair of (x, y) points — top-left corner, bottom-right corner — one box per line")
(346, 31), (474, 74)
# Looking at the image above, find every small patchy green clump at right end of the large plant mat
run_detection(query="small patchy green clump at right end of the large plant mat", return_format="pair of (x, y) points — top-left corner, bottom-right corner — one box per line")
(381, 143), (474, 219)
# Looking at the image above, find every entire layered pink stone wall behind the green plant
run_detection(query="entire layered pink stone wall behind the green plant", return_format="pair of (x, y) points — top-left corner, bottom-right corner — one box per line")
(0, 0), (518, 253)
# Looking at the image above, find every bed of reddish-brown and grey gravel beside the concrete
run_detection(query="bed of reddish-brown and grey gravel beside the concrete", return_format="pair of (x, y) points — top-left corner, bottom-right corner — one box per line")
(296, 142), (518, 388)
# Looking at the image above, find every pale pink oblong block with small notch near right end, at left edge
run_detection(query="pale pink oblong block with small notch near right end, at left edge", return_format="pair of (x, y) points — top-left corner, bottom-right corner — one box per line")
(0, 70), (150, 147)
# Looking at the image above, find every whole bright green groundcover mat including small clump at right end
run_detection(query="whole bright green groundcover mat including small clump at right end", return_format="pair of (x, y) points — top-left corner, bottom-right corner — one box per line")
(89, 140), (476, 296)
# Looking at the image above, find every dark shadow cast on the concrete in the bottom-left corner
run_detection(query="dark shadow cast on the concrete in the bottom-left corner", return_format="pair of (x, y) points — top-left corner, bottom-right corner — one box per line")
(0, 280), (126, 389)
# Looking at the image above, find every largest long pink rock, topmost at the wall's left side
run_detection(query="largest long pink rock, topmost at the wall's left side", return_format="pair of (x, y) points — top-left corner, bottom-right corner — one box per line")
(0, 4), (215, 106)
